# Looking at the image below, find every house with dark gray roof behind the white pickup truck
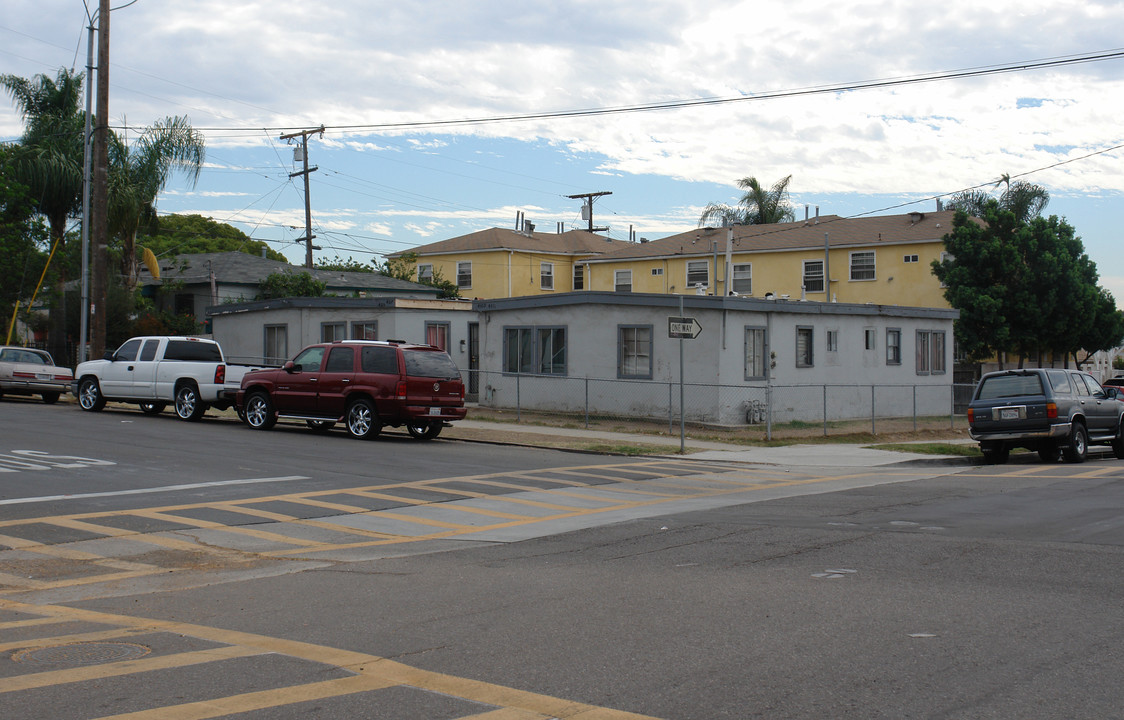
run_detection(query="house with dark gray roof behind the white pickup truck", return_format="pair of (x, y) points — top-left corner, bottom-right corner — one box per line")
(137, 253), (441, 321)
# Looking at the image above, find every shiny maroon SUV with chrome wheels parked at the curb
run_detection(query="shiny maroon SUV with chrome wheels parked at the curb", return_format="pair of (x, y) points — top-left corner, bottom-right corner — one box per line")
(237, 340), (466, 440)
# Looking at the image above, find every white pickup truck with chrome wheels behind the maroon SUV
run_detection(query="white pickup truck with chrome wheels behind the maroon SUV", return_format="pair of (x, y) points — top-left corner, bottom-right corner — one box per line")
(72, 336), (267, 420)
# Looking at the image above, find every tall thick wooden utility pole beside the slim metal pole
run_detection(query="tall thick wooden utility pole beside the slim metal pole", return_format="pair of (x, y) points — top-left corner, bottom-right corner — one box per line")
(89, 0), (109, 357)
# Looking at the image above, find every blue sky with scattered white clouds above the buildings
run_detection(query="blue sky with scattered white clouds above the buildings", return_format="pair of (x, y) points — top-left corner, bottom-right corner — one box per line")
(0, 0), (1124, 308)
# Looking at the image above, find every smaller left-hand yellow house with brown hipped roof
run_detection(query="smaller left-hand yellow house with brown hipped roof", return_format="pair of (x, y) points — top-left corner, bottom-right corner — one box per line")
(390, 228), (632, 298)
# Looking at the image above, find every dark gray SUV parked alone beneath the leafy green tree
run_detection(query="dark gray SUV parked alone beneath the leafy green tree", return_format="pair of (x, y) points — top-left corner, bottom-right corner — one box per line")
(968, 368), (1124, 463)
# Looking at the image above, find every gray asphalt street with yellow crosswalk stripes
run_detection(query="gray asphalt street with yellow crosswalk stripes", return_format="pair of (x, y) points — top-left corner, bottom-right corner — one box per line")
(0, 402), (1124, 720)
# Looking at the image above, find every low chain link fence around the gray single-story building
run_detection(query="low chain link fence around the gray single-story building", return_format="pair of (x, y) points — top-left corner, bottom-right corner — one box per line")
(463, 371), (973, 440)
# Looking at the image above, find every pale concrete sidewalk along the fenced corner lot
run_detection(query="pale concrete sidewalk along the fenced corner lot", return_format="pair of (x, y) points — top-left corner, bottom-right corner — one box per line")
(443, 420), (977, 467)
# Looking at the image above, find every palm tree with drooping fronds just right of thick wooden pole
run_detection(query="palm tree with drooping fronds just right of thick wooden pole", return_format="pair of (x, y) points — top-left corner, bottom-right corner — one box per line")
(109, 117), (206, 289)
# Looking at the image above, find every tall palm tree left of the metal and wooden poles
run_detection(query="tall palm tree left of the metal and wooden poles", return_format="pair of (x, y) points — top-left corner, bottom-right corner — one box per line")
(0, 69), (85, 358)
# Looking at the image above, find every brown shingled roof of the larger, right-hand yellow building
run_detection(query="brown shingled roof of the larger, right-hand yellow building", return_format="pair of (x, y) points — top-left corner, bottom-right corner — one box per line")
(591, 210), (955, 263)
